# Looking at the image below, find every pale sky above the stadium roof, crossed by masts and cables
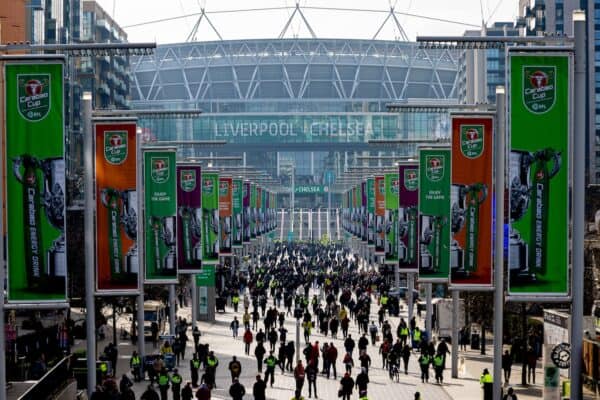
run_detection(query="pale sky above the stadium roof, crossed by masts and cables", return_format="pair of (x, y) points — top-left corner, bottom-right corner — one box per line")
(96, 0), (518, 44)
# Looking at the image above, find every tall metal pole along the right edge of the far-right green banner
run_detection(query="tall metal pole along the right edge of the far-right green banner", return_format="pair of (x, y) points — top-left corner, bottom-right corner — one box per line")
(571, 10), (591, 400)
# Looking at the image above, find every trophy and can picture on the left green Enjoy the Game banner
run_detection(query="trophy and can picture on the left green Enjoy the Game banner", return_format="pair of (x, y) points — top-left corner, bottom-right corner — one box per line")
(150, 216), (176, 275)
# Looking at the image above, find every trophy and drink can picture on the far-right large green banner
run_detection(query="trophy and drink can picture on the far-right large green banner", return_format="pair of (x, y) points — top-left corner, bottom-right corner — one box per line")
(509, 148), (561, 281)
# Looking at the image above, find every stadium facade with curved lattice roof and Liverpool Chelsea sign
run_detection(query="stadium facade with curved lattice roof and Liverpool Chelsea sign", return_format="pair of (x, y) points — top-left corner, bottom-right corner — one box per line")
(131, 39), (459, 207)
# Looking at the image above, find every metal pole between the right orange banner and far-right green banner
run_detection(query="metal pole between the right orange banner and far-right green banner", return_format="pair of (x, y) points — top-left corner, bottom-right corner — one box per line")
(493, 86), (506, 400)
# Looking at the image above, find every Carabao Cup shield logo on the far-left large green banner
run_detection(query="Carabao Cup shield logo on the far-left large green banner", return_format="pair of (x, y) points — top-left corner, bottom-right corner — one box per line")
(17, 74), (50, 122)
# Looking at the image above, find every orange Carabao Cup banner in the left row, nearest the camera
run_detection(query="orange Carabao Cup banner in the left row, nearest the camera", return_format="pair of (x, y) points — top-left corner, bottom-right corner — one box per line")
(94, 121), (140, 294)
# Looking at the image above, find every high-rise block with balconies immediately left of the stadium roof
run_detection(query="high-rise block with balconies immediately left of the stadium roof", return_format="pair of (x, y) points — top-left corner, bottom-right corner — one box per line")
(78, 1), (130, 109)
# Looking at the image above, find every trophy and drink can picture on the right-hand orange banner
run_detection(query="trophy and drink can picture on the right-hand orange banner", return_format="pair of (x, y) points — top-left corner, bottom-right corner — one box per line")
(450, 183), (488, 276)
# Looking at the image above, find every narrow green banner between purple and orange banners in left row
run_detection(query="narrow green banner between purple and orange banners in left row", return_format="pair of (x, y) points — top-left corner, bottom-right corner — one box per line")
(202, 173), (220, 265)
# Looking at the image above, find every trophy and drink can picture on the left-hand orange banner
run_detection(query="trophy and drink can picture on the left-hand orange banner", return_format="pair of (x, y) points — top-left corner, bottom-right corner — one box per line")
(100, 188), (139, 283)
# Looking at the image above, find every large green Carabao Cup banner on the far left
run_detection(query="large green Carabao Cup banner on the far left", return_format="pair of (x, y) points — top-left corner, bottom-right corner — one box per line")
(4, 57), (67, 303)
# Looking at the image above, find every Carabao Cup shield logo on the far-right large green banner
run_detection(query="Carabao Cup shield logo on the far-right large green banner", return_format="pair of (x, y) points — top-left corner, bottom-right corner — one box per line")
(523, 66), (556, 114)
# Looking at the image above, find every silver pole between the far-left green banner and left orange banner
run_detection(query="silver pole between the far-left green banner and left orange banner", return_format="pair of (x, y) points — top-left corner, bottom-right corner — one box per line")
(82, 92), (96, 397)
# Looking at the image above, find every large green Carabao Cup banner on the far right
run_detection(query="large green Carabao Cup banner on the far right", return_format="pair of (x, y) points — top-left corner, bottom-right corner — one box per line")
(508, 52), (573, 297)
